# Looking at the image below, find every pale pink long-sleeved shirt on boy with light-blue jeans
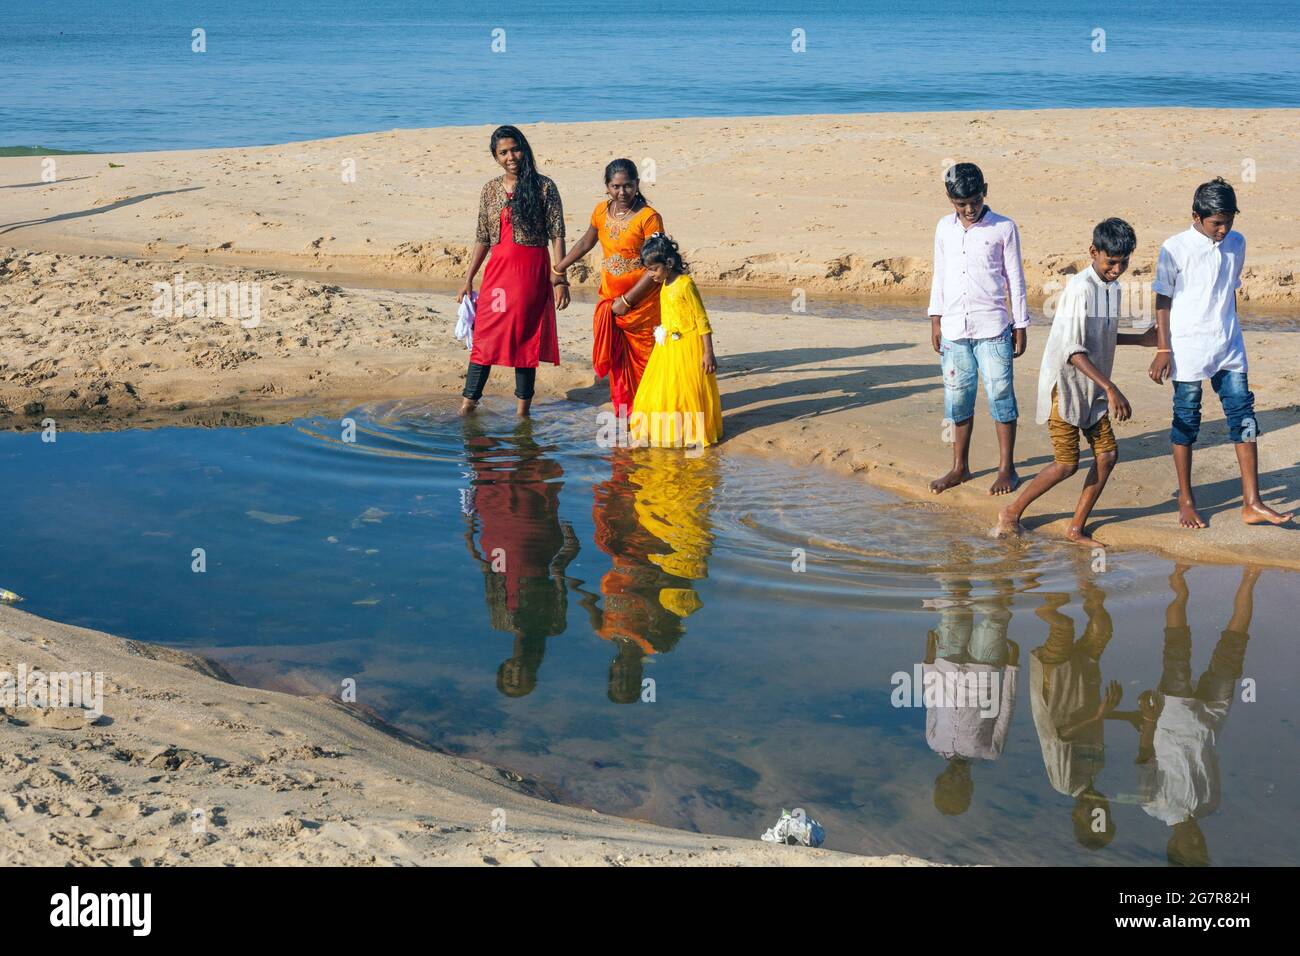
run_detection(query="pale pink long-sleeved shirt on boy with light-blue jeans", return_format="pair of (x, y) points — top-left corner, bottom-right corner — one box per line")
(930, 207), (1030, 339)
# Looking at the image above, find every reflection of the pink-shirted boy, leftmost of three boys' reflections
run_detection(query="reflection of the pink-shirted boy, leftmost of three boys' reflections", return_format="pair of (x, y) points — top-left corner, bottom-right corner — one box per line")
(922, 584), (1021, 816)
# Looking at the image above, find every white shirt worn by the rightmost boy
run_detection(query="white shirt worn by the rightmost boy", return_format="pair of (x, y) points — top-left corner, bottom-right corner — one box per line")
(1151, 226), (1245, 381)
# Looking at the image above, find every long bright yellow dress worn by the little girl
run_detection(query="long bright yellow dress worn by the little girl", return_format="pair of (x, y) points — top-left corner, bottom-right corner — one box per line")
(628, 276), (723, 447)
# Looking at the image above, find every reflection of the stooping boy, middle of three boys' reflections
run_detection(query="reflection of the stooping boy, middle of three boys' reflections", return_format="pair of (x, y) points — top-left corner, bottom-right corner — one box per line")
(1030, 585), (1122, 849)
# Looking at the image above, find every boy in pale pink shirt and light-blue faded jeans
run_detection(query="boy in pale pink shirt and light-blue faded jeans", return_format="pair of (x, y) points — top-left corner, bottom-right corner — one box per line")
(930, 163), (1030, 494)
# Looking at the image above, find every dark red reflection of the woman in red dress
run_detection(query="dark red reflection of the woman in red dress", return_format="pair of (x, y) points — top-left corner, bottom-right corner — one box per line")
(462, 421), (580, 697)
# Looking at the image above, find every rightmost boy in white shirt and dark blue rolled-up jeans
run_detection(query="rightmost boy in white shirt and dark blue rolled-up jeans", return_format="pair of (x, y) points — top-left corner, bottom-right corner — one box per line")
(1149, 177), (1291, 528)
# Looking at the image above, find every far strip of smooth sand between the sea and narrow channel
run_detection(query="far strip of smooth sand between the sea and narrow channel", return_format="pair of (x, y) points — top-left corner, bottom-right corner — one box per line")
(0, 109), (1300, 304)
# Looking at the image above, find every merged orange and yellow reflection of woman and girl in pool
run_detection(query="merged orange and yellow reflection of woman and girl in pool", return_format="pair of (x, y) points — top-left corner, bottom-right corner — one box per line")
(582, 449), (716, 704)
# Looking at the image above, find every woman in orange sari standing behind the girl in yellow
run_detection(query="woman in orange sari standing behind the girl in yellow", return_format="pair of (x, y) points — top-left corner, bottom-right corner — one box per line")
(554, 159), (663, 415)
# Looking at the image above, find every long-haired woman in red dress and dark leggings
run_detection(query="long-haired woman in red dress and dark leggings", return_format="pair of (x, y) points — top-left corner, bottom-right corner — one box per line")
(456, 126), (569, 418)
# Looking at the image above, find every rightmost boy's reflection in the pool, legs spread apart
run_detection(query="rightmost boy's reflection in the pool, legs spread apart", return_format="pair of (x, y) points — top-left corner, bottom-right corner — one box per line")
(1138, 566), (1258, 866)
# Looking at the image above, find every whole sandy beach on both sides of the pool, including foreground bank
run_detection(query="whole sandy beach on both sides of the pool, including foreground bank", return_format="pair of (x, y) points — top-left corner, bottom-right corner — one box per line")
(0, 109), (1300, 864)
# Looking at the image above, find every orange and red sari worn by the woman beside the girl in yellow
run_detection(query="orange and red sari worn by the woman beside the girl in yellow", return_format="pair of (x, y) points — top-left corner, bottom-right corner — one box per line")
(592, 202), (663, 411)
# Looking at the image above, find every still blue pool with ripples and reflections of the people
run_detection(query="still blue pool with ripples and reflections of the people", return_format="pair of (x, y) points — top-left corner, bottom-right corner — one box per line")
(0, 401), (1300, 865)
